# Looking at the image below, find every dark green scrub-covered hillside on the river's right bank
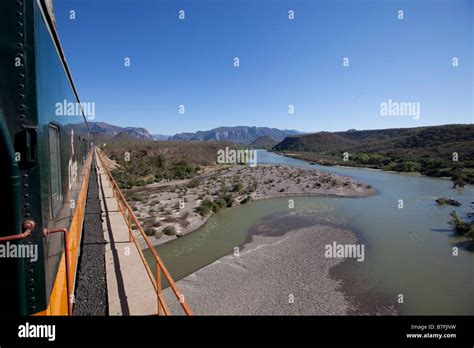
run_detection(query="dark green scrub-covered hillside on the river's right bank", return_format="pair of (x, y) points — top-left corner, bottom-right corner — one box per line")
(273, 125), (474, 188)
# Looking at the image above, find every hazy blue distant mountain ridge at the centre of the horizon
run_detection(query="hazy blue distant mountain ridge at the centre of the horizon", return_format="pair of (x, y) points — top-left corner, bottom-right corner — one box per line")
(168, 126), (302, 144)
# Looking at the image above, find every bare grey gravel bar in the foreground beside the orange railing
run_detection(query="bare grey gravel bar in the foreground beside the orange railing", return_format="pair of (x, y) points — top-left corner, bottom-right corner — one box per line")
(164, 220), (357, 315)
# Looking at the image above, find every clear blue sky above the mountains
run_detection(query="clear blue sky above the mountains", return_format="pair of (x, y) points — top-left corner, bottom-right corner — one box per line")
(54, 0), (474, 135)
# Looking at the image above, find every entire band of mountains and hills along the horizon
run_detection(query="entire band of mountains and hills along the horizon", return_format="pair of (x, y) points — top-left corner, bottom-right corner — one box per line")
(89, 122), (474, 184)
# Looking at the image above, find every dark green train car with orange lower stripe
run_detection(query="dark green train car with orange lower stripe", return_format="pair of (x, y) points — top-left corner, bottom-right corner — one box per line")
(0, 0), (92, 315)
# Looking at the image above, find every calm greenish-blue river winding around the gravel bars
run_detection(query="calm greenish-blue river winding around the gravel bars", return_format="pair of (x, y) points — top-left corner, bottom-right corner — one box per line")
(146, 150), (474, 315)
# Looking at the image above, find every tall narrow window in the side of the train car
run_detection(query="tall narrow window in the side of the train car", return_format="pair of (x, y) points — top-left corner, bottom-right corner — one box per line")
(49, 125), (62, 216)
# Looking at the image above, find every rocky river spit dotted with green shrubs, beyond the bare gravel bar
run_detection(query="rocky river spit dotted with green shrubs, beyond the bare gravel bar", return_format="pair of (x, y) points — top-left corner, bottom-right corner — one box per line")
(126, 165), (375, 245)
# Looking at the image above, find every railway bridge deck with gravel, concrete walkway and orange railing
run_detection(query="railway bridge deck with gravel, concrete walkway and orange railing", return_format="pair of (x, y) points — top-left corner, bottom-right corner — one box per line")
(73, 149), (192, 315)
